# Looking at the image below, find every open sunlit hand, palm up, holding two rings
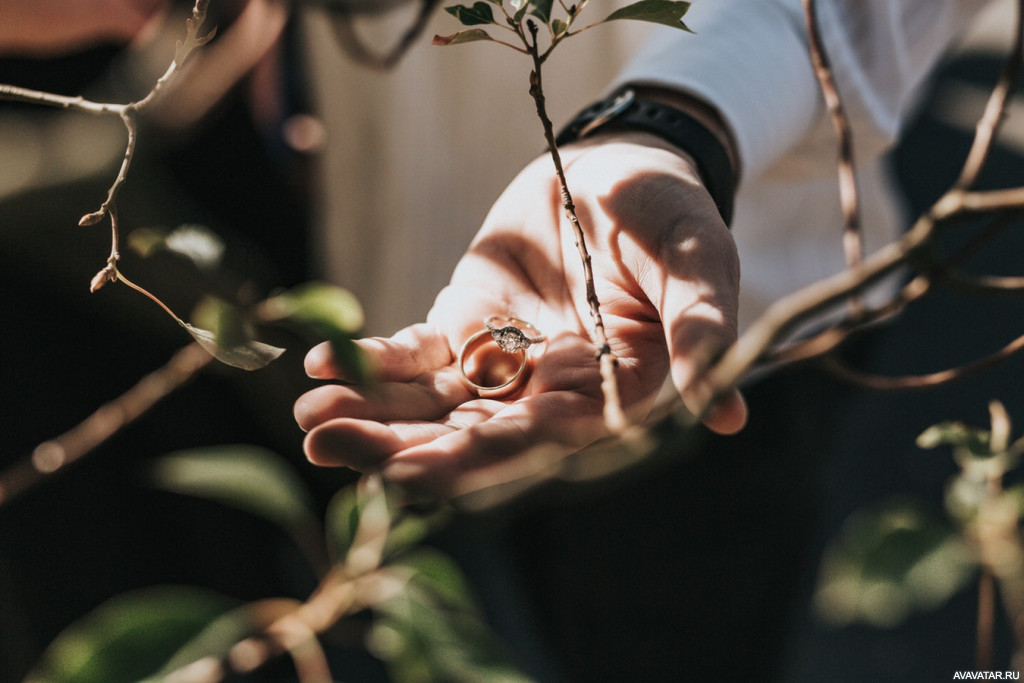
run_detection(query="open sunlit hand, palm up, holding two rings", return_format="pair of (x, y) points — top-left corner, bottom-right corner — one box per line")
(295, 133), (746, 497)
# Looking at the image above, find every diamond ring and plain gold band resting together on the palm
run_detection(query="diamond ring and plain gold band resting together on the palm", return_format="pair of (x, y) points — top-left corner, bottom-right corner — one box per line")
(458, 315), (545, 398)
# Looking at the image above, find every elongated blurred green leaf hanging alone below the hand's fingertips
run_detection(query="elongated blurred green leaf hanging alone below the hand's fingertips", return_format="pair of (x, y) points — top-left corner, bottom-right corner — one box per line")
(151, 445), (321, 557)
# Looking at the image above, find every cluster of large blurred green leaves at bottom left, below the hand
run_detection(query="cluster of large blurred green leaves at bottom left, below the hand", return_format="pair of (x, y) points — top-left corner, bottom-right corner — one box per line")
(29, 445), (528, 683)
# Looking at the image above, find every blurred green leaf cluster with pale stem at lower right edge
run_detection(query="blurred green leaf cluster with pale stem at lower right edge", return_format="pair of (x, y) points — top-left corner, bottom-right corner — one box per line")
(815, 402), (1024, 647)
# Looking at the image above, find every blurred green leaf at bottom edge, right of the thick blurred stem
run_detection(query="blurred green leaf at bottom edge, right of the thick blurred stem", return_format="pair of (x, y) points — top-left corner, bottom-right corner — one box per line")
(368, 549), (531, 683)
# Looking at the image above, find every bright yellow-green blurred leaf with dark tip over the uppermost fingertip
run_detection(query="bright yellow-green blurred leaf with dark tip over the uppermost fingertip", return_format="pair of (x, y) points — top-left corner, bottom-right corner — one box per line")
(260, 283), (370, 382)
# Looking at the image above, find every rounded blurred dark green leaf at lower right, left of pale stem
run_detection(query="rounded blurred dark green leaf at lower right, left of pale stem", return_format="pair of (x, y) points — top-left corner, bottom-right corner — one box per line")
(815, 502), (976, 628)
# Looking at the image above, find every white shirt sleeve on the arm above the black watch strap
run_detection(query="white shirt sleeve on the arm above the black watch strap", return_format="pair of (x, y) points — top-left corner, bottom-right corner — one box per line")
(618, 0), (987, 184)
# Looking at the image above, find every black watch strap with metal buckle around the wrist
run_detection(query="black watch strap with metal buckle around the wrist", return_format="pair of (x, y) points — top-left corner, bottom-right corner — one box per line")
(555, 88), (736, 225)
